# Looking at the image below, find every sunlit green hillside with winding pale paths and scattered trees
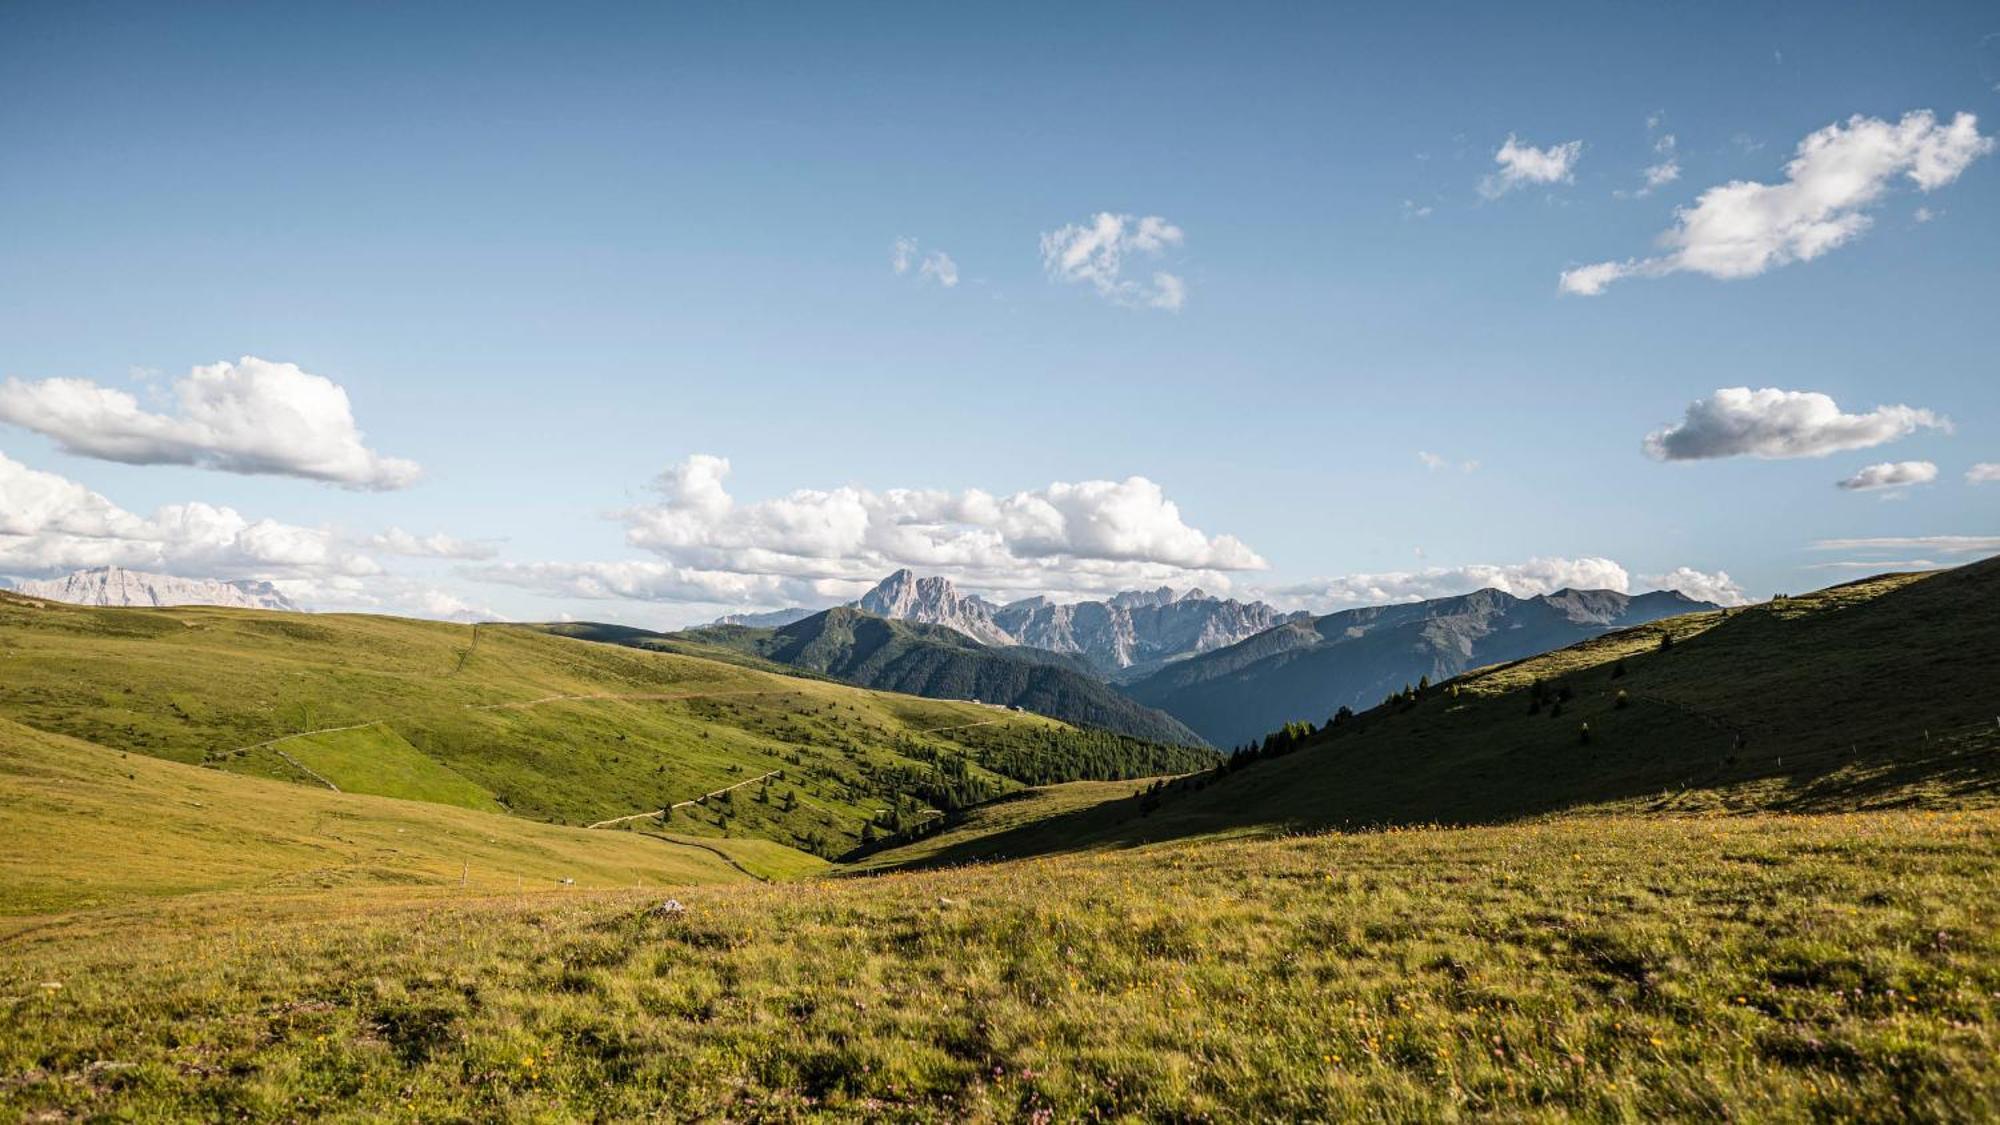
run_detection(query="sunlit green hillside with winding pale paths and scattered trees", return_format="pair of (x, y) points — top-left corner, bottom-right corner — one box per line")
(0, 595), (1216, 857)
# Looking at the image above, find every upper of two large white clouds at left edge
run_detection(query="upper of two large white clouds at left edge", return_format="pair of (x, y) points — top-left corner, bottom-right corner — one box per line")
(0, 356), (420, 488)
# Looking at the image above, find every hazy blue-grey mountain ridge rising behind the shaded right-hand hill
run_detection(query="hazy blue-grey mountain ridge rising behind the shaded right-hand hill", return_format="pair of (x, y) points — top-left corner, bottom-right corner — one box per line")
(1124, 591), (1716, 747)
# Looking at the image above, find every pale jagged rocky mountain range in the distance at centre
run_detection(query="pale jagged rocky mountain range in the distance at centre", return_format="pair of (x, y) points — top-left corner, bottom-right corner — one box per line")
(854, 571), (1306, 677)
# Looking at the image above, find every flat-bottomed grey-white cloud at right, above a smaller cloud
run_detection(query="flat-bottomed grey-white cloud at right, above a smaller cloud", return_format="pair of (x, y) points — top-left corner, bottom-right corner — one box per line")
(1644, 386), (1952, 460)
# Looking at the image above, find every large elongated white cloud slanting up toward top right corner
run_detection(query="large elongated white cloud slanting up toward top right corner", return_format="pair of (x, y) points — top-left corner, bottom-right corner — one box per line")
(1562, 110), (1994, 296)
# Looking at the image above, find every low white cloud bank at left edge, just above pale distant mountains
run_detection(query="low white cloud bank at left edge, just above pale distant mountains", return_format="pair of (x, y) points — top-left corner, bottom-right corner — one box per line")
(0, 446), (380, 579)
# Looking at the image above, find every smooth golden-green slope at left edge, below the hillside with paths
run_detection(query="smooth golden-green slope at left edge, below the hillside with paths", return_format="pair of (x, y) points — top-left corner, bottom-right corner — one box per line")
(0, 721), (812, 916)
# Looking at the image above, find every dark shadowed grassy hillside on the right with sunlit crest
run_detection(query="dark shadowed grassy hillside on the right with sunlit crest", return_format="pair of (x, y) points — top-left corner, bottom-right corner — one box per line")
(920, 560), (2000, 859)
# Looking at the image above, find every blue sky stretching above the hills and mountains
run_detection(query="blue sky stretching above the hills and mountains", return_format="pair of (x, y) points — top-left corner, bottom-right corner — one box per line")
(0, 4), (2000, 625)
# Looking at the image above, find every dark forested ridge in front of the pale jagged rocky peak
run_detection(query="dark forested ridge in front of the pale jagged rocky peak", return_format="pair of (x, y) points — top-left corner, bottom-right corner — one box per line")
(552, 607), (1204, 747)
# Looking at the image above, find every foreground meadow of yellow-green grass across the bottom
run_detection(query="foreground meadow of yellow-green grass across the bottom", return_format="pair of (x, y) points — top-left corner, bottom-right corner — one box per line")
(0, 804), (2000, 1121)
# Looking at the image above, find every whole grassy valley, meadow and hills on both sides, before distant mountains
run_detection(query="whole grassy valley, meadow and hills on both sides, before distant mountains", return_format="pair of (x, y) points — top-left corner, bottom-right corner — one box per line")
(0, 563), (2000, 1121)
